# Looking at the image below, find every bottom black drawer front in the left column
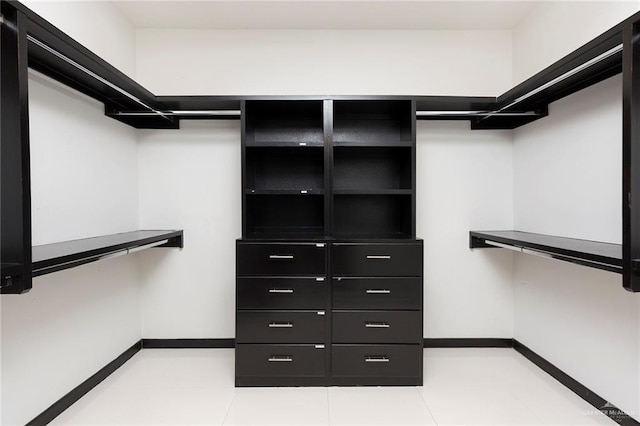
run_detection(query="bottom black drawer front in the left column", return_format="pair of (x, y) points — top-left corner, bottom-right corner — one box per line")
(236, 344), (326, 377)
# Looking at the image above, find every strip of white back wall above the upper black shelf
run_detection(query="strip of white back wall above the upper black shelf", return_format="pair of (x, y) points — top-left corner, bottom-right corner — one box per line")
(137, 29), (511, 96)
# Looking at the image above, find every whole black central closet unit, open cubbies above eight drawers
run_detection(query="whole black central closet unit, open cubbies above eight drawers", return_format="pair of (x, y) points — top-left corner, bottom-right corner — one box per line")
(236, 98), (422, 386)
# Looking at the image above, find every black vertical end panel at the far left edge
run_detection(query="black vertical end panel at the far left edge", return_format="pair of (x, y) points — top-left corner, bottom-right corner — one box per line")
(0, 2), (31, 294)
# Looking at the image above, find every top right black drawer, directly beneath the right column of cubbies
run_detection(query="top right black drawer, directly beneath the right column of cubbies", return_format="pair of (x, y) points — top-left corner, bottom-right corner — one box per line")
(331, 241), (422, 277)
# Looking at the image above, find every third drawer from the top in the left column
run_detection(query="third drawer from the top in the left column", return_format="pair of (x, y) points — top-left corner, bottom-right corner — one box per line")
(236, 311), (327, 343)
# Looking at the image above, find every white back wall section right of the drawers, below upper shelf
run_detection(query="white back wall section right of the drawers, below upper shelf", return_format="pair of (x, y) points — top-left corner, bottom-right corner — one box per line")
(416, 121), (513, 338)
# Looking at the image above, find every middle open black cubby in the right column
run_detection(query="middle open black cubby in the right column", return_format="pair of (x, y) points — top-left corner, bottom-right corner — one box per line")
(333, 147), (412, 193)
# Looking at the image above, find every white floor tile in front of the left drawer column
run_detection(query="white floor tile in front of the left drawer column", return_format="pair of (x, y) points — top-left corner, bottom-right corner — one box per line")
(224, 388), (329, 425)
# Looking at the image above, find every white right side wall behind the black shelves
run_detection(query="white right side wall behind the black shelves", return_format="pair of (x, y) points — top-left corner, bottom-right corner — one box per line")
(513, 2), (640, 419)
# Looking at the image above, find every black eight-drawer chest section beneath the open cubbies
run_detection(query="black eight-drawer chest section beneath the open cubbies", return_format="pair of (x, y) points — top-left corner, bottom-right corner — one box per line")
(236, 240), (423, 386)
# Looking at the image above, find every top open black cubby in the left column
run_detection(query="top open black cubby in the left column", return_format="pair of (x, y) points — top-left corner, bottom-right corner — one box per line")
(244, 100), (324, 146)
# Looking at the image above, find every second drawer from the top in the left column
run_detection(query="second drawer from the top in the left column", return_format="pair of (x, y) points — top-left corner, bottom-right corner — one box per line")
(236, 277), (327, 309)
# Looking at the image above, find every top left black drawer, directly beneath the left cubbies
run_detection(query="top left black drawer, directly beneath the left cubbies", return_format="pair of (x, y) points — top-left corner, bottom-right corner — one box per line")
(236, 241), (326, 277)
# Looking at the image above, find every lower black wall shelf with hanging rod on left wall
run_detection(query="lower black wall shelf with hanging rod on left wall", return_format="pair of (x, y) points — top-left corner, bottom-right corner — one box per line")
(32, 230), (183, 277)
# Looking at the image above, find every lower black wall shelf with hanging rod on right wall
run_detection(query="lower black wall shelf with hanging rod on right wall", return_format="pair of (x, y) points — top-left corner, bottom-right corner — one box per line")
(469, 231), (622, 274)
